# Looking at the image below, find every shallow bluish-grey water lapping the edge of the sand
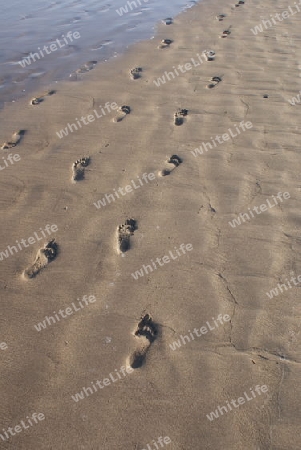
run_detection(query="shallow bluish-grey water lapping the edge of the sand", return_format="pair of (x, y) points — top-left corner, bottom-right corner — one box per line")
(0, 0), (196, 104)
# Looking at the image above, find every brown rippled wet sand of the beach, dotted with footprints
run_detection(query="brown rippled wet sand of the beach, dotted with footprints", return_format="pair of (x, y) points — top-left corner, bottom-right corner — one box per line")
(0, 0), (301, 450)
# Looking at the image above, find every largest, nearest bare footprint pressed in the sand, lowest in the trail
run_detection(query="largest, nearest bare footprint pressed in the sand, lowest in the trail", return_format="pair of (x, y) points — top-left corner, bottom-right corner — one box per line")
(128, 314), (158, 369)
